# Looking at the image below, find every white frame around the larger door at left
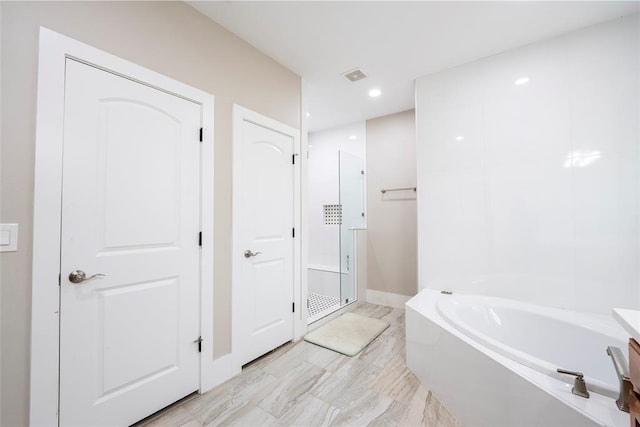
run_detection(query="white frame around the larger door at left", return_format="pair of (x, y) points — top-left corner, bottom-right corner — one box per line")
(30, 27), (214, 426)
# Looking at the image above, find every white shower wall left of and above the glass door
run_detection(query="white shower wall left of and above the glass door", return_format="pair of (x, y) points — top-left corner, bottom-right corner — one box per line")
(307, 122), (366, 270)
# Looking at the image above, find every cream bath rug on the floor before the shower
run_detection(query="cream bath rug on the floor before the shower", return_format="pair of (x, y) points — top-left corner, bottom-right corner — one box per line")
(304, 313), (389, 356)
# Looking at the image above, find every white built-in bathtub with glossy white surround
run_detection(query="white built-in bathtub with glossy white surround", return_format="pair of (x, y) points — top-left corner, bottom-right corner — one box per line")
(406, 290), (629, 427)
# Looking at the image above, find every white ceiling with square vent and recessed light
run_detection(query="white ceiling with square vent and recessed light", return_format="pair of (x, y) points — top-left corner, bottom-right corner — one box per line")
(187, 1), (640, 132)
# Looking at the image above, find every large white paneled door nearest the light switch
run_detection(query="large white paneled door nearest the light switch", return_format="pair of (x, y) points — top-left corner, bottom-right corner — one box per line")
(59, 59), (201, 426)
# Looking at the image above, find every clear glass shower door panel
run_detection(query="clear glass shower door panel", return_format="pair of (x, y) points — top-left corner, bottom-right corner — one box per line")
(338, 151), (364, 305)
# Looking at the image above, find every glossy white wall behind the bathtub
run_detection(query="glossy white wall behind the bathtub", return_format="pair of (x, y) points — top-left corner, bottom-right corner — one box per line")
(416, 15), (640, 313)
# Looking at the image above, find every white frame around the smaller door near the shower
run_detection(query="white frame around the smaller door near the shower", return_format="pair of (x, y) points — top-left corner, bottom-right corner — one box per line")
(231, 104), (306, 371)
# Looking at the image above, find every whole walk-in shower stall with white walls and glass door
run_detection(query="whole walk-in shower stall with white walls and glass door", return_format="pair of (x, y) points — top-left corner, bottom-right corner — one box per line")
(307, 124), (366, 323)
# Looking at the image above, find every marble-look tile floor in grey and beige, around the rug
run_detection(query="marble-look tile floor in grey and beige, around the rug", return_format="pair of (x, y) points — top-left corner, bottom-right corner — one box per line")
(137, 304), (460, 427)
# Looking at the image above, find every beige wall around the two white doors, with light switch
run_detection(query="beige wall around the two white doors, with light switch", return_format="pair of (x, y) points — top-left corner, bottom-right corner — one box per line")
(0, 2), (301, 426)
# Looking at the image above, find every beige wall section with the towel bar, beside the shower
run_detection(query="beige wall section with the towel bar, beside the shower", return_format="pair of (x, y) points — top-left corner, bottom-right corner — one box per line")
(367, 110), (418, 296)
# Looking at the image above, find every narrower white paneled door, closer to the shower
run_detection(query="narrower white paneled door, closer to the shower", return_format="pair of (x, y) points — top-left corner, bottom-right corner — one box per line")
(233, 114), (295, 364)
